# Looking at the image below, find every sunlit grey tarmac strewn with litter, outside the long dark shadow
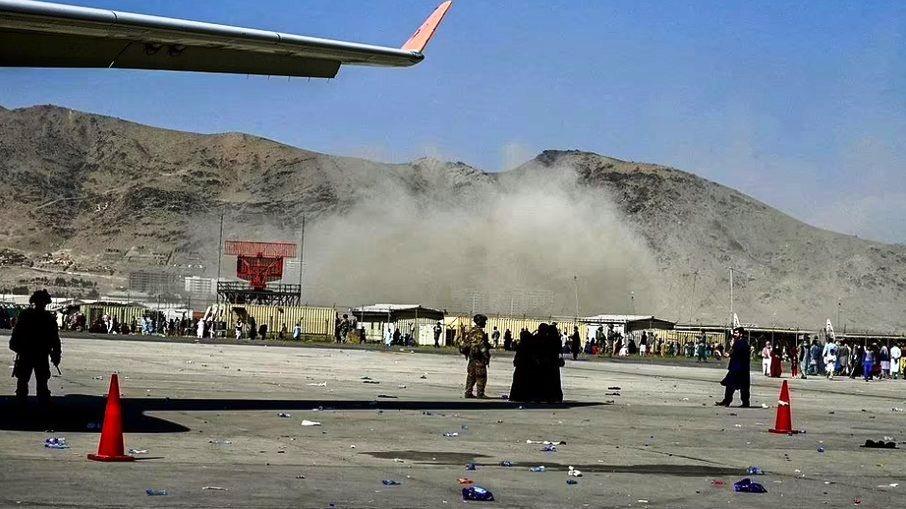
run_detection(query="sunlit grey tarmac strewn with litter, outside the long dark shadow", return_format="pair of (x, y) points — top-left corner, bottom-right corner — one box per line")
(0, 337), (906, 509)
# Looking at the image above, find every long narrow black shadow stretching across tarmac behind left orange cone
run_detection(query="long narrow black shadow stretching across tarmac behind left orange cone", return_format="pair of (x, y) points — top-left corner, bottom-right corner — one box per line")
(0, 394), (602, 433)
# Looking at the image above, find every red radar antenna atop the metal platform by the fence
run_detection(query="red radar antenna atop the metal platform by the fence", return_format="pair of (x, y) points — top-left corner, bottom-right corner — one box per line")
(223, 240), (296, 292)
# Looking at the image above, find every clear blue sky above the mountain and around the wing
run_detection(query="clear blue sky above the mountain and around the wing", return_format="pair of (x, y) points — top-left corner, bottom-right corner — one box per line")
(0, 0), (906, 243)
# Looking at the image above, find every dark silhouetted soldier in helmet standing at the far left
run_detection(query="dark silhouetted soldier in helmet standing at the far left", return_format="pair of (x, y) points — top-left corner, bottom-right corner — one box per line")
(9, 290), (61, 407)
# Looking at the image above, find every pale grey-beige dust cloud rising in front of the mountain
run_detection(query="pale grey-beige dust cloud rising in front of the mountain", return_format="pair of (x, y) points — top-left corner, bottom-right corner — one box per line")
(303, 163), (656, 316)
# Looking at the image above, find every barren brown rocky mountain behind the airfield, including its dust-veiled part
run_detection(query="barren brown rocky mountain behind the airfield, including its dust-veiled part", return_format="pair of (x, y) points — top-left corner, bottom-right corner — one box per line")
(0, 106), (906, 331)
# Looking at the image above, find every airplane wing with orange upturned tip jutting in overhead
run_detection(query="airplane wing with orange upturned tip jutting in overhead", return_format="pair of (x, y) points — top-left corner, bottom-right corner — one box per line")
(0, 0), (452, 78)
